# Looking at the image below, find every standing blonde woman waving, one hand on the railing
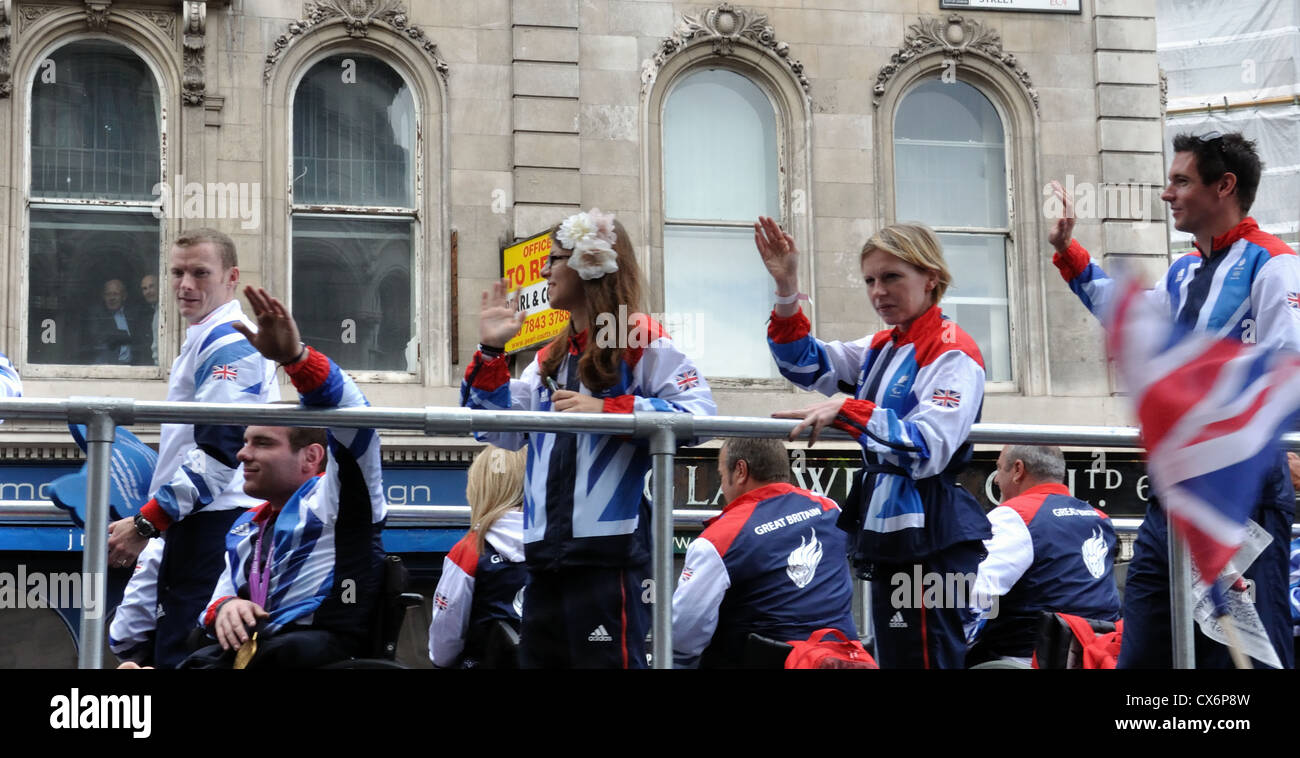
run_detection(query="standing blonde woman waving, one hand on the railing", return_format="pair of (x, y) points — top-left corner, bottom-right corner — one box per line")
(754, 217), (992, 668)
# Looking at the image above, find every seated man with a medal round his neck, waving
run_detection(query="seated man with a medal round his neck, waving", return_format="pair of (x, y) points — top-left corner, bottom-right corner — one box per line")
(183, 287), (387, 668)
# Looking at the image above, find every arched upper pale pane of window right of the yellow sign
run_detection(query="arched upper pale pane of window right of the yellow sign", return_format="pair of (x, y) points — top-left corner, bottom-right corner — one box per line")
(663, 70), (780, 221)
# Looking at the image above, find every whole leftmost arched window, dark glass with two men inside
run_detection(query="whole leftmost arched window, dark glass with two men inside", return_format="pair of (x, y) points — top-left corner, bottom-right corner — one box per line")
(26, 40), (163, 365)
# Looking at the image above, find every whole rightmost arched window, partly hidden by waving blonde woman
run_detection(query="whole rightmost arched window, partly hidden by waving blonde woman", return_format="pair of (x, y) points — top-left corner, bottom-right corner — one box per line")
(893, 79), (1013, 382)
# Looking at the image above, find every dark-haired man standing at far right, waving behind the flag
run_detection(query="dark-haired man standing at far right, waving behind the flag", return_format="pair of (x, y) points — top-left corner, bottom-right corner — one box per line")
(1048, 133), (1300, 668)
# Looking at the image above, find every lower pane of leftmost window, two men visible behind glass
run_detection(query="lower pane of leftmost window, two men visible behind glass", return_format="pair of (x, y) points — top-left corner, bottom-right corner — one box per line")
(27, 208), (161, 365)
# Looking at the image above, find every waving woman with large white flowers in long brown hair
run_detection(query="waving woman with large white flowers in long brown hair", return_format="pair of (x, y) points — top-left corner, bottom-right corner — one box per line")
(460, 208), (718, 668)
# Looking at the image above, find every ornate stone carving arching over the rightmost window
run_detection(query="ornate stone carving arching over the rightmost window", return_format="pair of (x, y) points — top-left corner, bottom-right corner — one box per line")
(872, 13), (1039, 111)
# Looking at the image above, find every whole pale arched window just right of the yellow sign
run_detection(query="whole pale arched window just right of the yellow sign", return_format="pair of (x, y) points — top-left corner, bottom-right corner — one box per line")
(663, 69), (781, 378)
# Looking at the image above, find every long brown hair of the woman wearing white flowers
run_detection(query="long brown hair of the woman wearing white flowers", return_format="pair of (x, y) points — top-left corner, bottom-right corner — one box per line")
(542, 214), (642, 391)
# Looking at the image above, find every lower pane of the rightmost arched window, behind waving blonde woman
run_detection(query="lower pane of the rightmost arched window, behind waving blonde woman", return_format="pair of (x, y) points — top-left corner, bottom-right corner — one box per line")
(939, 234), (1011, 382)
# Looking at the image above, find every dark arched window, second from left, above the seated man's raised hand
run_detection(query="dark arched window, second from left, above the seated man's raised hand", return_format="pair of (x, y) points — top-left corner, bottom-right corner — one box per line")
(291, 53), (419, 372)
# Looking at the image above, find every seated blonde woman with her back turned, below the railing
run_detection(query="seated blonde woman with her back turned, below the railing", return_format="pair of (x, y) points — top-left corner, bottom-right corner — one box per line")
(429, 445), (528, 668)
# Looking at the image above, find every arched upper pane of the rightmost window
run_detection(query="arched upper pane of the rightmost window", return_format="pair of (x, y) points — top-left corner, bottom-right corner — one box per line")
(894, 81), (1008, 228)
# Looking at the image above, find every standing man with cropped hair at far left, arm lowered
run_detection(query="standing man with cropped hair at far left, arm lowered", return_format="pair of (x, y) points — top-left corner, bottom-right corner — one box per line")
(108, 229), (280, 667)
